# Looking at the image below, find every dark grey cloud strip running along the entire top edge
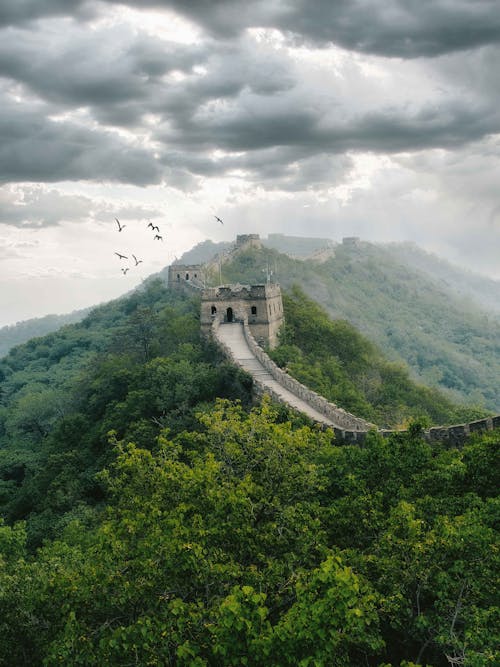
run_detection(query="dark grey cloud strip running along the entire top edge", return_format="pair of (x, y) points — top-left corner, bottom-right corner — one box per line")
(0, 0), (500, 58)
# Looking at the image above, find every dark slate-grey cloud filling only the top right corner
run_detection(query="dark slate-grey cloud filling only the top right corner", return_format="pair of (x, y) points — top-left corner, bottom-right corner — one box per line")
(277, 0), (500, 58)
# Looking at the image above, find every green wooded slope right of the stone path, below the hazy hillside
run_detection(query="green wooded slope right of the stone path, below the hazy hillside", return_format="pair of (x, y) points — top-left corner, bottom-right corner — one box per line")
(270, 287), (486, 427)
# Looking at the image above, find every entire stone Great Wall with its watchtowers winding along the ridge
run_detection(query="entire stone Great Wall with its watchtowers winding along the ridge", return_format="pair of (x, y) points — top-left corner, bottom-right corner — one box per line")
(168, 234), (500, 445)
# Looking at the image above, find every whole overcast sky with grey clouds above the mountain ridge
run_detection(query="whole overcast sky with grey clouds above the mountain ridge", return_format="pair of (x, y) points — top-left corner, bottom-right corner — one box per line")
(0, 0), (500, 326)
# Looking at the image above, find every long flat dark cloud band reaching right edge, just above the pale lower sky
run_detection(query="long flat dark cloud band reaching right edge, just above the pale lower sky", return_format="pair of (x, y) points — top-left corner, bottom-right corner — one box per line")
(157, 92), (500, 163)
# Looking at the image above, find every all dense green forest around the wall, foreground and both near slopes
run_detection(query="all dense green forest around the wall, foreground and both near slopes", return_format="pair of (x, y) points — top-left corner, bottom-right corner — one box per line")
(0, 281), (500, 667)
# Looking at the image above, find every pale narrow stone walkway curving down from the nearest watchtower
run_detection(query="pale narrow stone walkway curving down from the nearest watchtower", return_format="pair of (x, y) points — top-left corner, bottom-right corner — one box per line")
(216, 322), (340, 428)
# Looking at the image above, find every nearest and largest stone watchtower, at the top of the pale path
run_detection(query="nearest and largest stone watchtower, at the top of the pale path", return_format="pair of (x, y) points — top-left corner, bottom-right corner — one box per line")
(201, 284), (284, 348)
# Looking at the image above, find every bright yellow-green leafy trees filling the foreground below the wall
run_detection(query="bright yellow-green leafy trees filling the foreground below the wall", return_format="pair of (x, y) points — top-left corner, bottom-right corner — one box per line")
(0, 401), (500, 667)
